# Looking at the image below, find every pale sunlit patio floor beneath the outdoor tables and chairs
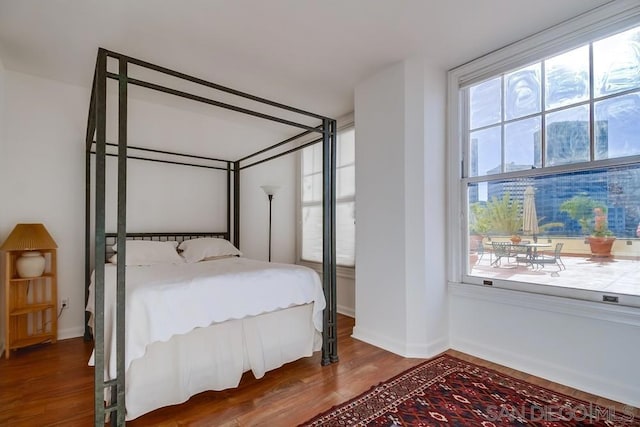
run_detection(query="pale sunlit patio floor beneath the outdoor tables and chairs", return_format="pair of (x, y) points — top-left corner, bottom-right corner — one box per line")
(471, 253), (640, 295)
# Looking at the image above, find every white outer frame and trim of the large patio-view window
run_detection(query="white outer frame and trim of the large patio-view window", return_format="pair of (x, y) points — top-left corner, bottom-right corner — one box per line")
(447, 0), (640, 307)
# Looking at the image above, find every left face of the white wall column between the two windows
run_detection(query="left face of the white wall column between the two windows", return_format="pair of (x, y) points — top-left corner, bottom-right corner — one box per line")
(353, 65), (406, 352)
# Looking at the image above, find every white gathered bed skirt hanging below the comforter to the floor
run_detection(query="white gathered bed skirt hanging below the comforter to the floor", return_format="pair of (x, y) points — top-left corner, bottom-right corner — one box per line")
(125, 303), (322, 420)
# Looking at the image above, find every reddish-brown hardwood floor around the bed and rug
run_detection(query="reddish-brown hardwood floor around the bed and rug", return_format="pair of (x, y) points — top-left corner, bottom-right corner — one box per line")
(0, 316), (624, 427)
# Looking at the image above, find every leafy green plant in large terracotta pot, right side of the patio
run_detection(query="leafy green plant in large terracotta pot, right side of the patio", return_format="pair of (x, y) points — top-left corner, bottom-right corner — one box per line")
(560, 194), (616, 258)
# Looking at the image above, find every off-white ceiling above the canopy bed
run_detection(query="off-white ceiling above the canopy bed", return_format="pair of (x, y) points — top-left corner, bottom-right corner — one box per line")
(0, 0), (609, 157)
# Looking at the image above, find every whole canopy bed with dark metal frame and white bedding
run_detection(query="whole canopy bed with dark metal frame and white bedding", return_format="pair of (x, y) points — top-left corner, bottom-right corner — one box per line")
(85, 48), (338, 425)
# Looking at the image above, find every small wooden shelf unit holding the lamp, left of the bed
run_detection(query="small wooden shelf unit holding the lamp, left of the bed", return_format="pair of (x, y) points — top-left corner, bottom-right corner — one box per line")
(3, 249), (58, 359)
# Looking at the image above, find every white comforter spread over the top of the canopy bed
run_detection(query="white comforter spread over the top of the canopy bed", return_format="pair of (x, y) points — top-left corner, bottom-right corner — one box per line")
(87, 257), (326, 378)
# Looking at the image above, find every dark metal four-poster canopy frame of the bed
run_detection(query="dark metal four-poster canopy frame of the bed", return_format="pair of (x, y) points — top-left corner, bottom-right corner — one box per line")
(85, 48), (338, 425)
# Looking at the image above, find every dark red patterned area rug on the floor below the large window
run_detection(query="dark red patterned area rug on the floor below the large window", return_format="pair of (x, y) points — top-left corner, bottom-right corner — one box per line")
(301, 355), (640, 427)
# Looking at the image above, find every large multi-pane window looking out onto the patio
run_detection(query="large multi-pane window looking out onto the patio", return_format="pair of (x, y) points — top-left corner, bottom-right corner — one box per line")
(457, 16), (640, 305)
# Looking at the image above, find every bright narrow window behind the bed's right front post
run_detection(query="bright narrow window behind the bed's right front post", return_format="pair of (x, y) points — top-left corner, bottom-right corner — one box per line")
(301, 126), (356, 267)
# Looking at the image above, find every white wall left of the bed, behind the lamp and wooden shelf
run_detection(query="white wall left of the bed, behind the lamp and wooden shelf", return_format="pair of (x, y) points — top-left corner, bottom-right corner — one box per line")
(0, 71), (88, 337)
